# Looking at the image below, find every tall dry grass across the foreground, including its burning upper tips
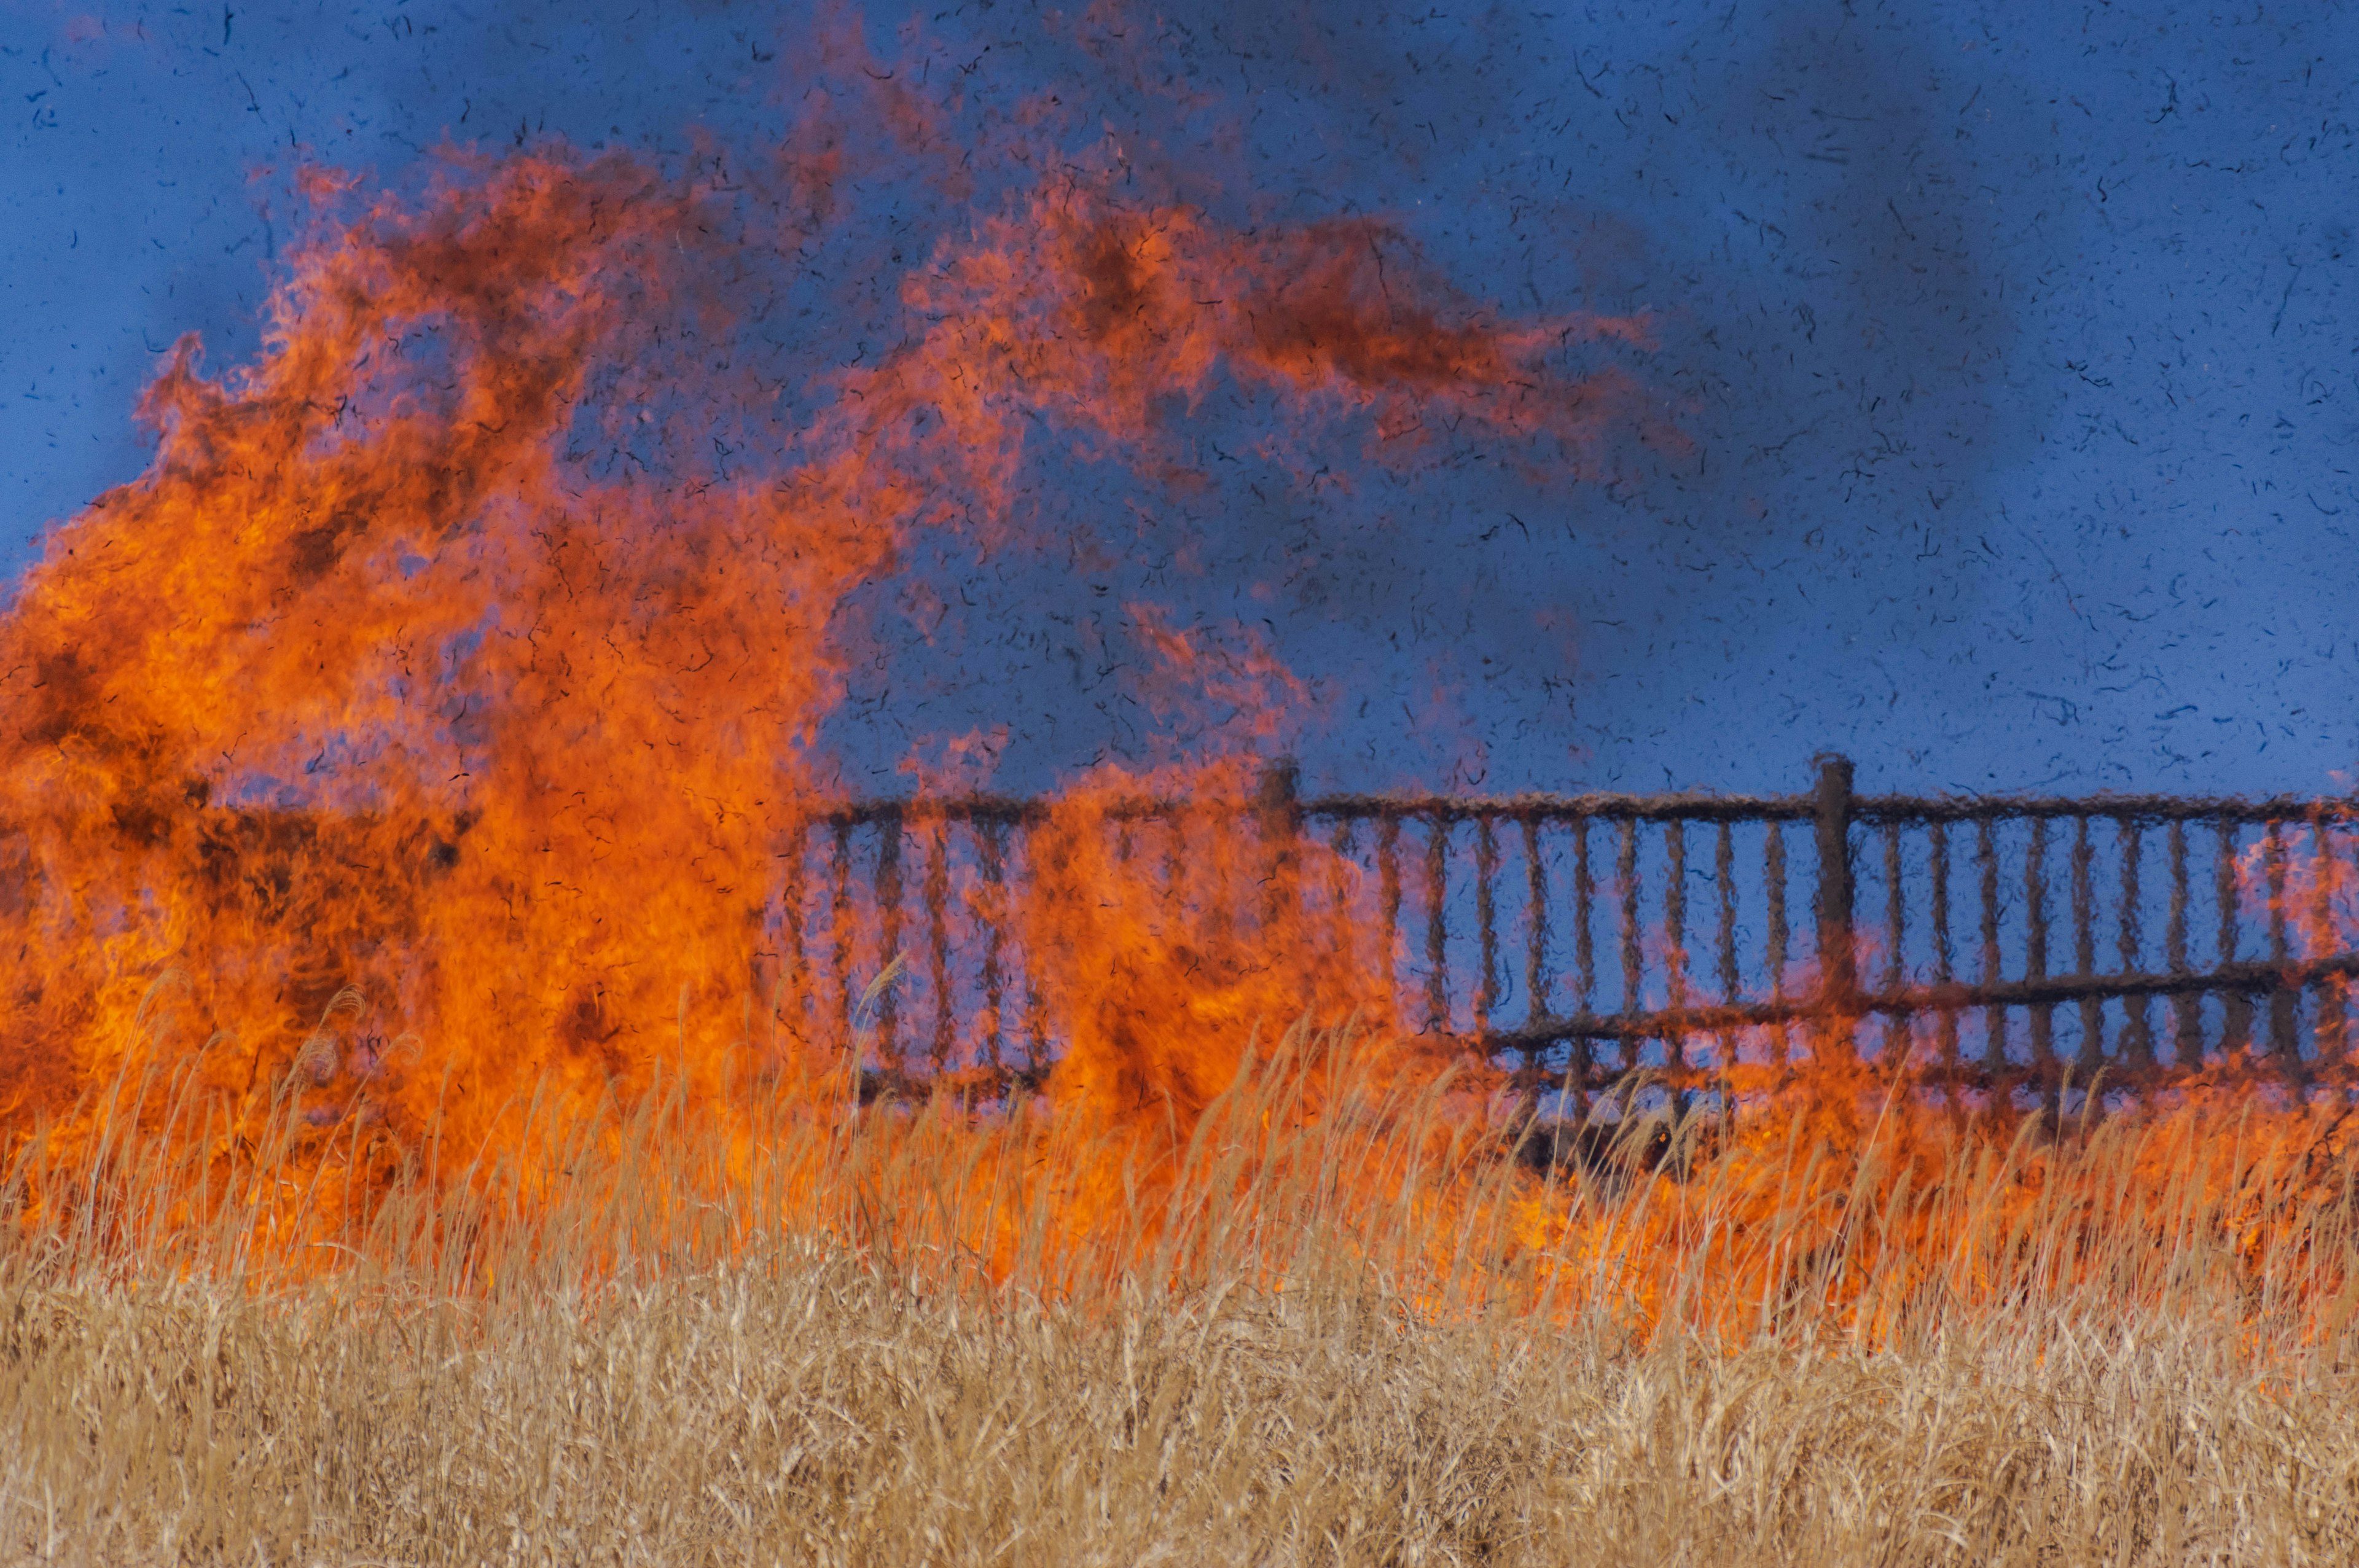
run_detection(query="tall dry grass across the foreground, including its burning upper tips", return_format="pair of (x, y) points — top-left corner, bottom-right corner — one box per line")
(0, 1009), (2359, 1568)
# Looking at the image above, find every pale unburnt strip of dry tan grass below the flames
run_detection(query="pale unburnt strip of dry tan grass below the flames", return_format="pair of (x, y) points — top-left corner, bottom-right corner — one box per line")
(0, 1254), (2359, 1568)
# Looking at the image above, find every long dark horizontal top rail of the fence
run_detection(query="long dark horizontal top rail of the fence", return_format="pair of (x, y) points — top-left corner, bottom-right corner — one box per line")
(804, 790), (2359, 828)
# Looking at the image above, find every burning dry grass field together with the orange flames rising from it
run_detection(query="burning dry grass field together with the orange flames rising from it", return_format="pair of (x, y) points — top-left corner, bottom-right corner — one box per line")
(0, 49), (2359, 1568)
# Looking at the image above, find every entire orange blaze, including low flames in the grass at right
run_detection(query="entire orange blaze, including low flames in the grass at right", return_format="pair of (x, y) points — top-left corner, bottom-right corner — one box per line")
(0, 85), (2350, 1332)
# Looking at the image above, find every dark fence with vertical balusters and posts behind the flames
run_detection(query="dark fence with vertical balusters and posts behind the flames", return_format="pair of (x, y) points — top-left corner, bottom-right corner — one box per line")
(776, 757), (2359, 1096)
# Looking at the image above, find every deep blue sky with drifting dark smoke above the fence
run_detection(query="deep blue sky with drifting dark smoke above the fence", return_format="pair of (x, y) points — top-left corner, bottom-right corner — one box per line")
(0, 0), (2359, 792)
